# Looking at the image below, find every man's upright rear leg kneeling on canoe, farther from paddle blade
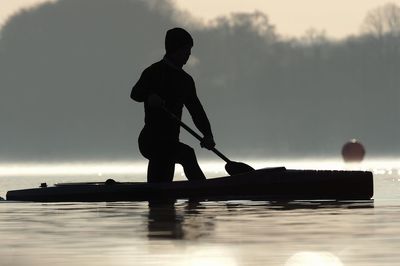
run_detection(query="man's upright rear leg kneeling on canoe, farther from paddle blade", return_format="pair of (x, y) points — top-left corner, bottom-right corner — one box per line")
(147, 158), (175, 183)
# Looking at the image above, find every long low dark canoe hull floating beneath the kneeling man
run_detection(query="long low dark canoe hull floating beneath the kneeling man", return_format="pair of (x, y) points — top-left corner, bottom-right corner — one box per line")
(7, 169), (373, 202)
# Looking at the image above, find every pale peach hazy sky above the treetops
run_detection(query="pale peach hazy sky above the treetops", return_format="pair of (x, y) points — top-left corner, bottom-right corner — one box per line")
(0, 0), (400, 38)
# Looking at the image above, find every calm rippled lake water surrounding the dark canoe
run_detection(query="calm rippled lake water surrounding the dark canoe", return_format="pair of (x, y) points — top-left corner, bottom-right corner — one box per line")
(0, 160), (400, 266)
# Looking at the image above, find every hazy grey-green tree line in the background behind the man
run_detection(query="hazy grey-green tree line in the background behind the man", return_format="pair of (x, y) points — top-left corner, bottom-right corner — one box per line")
(0, 0), (400, 160)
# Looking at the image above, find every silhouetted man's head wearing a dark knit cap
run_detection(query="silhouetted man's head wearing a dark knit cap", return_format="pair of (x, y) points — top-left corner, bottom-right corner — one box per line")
(165, 28), (193, 66)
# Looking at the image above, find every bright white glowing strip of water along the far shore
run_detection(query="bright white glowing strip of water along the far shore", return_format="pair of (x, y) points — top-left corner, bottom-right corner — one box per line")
(0, 158), (399, 176)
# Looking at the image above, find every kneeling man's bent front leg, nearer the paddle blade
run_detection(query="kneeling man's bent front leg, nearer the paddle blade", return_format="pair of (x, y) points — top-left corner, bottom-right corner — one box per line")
(175, 142), (206, 181)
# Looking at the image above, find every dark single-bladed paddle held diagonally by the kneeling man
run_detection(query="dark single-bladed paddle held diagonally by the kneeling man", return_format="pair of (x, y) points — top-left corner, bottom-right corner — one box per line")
(162, 106), (254, 175)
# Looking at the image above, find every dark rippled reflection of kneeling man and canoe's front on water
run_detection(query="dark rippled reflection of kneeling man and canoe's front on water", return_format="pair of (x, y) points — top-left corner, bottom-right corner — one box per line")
(147, 200), (374, 240)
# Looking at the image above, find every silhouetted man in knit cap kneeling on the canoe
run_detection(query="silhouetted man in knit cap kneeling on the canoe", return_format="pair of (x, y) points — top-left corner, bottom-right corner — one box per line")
(131, 28), (215, 182)
